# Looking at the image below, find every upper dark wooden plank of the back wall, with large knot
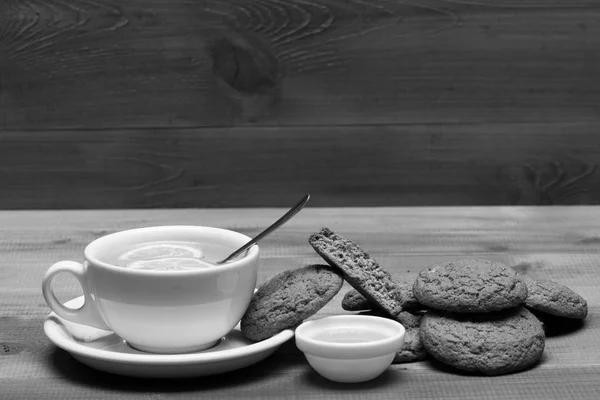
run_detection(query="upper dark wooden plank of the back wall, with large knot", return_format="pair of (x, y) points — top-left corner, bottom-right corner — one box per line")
(0, 0), (600, 129)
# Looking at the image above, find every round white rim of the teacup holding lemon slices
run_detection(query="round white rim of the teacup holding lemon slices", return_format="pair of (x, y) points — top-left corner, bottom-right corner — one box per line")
(84, 225), (259, 277)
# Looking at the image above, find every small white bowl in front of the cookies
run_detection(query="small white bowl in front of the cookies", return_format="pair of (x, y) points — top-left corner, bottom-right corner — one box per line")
(296, 315), (405, 382)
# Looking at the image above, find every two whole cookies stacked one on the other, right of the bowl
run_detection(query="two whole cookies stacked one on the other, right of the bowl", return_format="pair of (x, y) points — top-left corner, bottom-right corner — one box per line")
(413, 259), (545, 375)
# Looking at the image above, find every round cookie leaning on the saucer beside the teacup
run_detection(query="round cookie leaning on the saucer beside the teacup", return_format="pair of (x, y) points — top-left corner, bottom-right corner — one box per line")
(240, 264), (344, 341)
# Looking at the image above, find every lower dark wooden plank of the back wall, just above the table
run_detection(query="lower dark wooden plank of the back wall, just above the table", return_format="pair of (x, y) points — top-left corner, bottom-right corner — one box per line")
(0, 123), (600, 209)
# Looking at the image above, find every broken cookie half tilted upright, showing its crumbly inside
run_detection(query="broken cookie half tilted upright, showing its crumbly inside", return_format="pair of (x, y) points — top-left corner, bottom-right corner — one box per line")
(308, 228), (402, 317)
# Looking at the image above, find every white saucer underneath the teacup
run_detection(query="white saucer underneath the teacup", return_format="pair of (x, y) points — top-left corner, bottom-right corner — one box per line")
(44, 296), (294, 378)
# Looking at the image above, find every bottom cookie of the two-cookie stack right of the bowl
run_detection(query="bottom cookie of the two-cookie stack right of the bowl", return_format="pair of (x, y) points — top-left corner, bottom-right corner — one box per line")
(421, 307), (545, 375)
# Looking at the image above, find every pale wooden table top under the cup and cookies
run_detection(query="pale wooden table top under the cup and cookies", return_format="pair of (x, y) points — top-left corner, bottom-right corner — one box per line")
(0, 206), (600, 400)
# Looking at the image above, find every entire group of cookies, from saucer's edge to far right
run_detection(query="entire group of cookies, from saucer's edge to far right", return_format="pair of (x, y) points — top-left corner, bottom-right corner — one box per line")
(241, 228), (587, 375)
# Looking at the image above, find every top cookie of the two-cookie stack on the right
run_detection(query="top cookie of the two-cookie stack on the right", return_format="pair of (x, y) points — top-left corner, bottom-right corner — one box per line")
(413, 259), (527, 313)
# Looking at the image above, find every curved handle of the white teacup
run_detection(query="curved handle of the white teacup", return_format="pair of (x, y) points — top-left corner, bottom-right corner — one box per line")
(42, 261), (110, 330)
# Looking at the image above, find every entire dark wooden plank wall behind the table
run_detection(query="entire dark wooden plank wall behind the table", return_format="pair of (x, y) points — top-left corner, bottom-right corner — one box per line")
(0, 0), (600, 209)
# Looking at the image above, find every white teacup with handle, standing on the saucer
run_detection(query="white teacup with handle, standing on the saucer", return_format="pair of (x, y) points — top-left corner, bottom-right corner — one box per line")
(42, 226), (259, 353)
